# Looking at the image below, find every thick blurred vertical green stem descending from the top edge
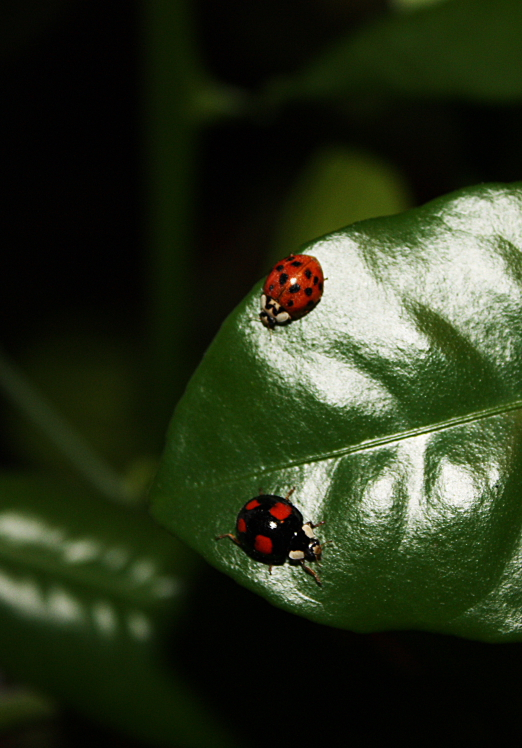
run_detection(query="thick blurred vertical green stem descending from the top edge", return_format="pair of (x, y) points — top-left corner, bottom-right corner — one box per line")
(143, 0), (205, 448)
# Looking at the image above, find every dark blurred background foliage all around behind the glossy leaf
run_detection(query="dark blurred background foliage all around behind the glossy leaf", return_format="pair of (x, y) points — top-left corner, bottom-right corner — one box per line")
(0, 0), (522, 747)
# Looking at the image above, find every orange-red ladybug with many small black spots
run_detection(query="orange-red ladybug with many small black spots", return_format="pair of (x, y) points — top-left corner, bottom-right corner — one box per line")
(259, 255), (324, 330)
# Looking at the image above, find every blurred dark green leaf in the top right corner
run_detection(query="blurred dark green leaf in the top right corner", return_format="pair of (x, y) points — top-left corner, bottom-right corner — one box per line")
(267, 0), (522, 103)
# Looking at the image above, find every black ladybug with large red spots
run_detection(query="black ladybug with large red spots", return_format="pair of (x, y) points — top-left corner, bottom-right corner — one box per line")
(217, 489), (324, 586)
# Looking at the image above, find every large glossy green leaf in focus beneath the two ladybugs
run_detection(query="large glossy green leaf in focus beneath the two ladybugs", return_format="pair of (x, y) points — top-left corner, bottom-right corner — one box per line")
(152, 184), (522, 640)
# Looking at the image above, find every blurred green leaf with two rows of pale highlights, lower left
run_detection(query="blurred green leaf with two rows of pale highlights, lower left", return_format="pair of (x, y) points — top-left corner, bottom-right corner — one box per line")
(0, 474), (234, 748)
